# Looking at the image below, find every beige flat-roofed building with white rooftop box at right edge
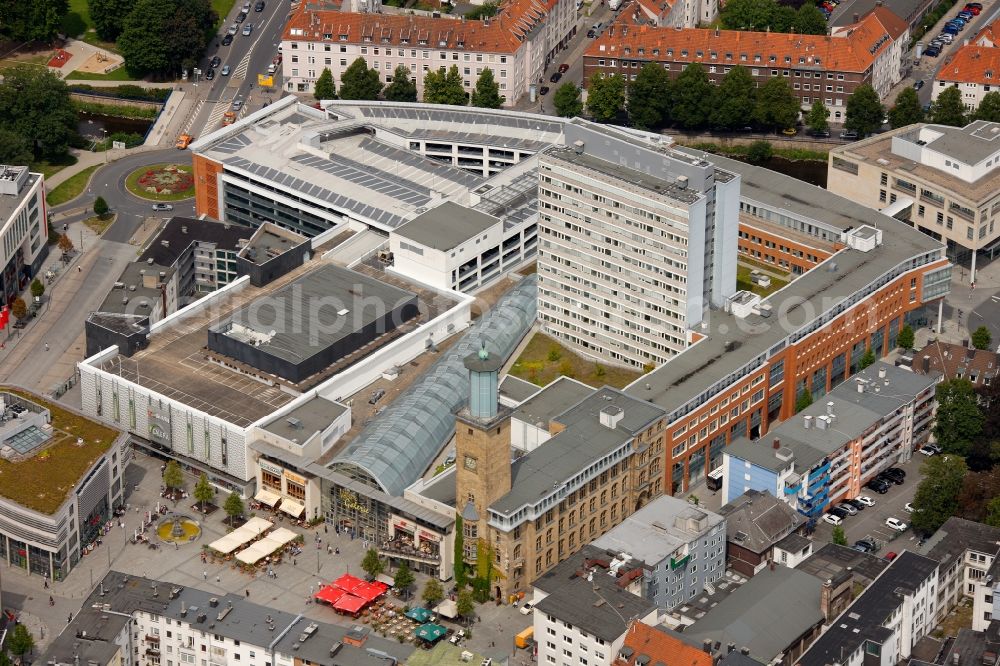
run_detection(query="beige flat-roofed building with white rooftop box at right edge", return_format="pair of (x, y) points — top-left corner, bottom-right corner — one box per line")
(827, 120), (1000, 282)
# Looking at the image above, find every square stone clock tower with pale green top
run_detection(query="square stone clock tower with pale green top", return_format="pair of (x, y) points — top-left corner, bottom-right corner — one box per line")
(455, 343), (510, 561)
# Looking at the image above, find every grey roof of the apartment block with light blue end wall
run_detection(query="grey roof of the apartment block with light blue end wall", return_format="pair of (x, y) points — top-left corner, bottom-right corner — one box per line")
(726, 361), (940, 472)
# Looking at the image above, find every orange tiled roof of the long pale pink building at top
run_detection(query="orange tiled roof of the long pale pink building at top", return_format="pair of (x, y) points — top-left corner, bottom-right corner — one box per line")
(283, 0), (554, 53)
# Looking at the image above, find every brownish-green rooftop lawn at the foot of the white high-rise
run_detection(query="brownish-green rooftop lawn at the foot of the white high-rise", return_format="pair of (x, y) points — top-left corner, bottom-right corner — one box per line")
(510, 333), (642, 388)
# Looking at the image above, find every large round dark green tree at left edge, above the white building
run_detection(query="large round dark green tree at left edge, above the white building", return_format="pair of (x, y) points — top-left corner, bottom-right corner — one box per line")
(0, 65), (77, 158)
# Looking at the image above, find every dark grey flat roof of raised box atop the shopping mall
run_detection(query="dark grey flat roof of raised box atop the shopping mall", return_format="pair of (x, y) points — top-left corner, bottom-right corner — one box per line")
(212, 264), (417, 363)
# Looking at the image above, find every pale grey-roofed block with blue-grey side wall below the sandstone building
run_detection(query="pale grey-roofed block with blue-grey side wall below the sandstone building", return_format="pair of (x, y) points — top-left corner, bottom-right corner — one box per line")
(593, 496), (726, 609)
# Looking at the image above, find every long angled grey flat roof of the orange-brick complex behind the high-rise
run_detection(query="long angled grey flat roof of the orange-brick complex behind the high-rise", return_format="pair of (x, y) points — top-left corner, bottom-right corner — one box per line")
(625, 153), (944, 420)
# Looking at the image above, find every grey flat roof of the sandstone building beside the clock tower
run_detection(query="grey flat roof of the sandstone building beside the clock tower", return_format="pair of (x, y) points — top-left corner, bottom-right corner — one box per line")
(490, 386), (663, 514)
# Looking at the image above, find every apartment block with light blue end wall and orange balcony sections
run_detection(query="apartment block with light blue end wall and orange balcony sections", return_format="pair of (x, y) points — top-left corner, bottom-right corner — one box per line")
(722, 361), (940, 517)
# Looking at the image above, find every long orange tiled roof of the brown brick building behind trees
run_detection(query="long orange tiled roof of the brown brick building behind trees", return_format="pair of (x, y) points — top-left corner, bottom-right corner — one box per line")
(584, 8), (907, 72)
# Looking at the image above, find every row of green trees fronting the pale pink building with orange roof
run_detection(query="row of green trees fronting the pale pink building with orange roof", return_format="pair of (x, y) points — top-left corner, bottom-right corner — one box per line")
(313, 58), (506, 109)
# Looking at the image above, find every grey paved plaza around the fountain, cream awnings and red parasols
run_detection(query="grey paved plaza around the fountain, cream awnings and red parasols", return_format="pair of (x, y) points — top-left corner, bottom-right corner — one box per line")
(0, 453), (531, 663)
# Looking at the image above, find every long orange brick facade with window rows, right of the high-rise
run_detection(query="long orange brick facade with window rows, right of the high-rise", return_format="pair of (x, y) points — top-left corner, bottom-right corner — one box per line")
(663, 261), (944, 494)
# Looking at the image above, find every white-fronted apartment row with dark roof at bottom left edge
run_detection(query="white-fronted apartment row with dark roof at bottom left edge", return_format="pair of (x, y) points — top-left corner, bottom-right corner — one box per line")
(40, 571), (413, 666)
